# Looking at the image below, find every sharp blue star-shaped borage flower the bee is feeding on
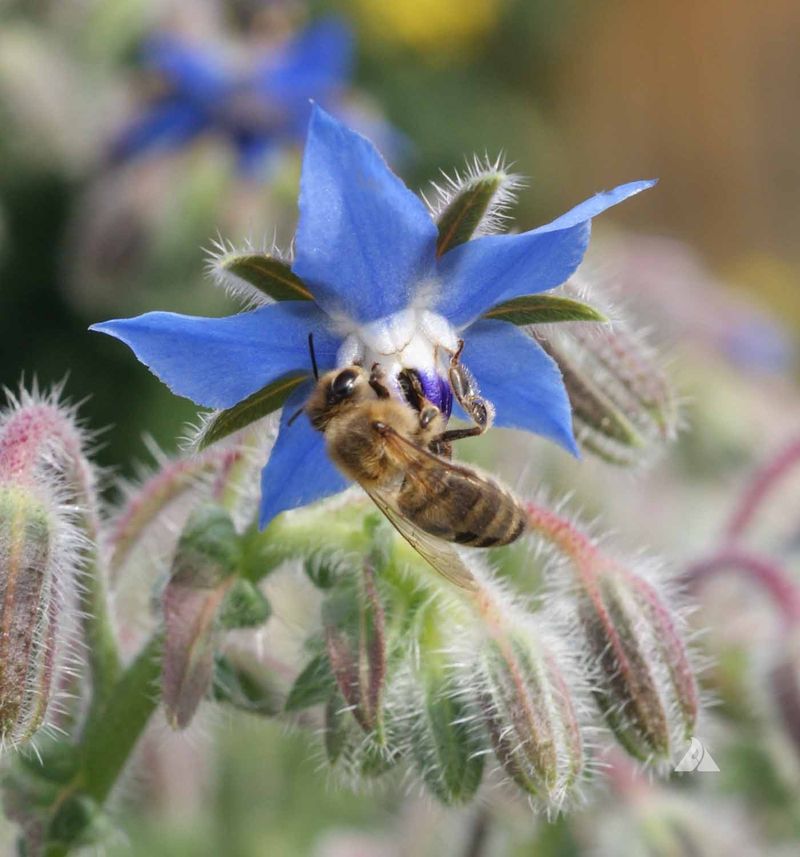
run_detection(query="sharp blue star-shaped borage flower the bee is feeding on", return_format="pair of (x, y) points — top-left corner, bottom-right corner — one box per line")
(92, 107), (654, 527)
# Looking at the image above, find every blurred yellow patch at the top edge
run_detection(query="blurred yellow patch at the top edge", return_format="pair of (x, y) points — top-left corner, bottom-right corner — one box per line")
(351, 0), (504, 60)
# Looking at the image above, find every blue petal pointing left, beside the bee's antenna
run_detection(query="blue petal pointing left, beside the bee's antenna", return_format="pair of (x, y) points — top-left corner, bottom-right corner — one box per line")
(91, 301), (339, 408)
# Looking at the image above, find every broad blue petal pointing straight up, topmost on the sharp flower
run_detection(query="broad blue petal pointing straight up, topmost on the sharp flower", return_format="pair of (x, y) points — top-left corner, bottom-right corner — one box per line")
(293, 107), (437, 322)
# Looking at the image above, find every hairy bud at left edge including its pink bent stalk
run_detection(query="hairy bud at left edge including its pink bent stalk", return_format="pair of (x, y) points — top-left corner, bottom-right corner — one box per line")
(0, 393), (86, 746)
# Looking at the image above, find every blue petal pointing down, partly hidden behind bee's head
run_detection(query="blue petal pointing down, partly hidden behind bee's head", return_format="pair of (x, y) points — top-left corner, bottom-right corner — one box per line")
(258, 383), (350, 530)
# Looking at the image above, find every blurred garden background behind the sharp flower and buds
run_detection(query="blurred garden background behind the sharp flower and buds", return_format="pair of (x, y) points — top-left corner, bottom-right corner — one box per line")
(0, 0), (800, 857)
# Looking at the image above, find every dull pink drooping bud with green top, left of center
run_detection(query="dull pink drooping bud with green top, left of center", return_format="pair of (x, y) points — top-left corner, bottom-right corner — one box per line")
(163, 504), (239, 729)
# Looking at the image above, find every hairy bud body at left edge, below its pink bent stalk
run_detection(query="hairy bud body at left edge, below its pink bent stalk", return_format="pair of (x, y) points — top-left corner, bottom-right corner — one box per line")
(0, 484), (67, 746)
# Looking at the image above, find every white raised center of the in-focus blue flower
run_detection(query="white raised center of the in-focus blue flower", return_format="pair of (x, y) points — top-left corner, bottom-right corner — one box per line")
(337, 307), (458, 392)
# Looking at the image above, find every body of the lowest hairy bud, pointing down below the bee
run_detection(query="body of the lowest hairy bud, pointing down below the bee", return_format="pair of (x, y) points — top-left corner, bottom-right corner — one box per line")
(480, 628), (584, 809)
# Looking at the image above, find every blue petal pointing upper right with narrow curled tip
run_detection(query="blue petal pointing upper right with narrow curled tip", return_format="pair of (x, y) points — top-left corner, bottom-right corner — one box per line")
(436, 181), (655, 325)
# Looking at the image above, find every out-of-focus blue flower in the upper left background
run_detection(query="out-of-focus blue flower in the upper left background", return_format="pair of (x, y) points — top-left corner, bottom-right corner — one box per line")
(110, 18), (353, 175)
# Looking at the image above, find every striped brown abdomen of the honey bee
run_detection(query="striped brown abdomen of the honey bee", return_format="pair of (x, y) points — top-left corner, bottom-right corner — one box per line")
(398, 472), (527, 548)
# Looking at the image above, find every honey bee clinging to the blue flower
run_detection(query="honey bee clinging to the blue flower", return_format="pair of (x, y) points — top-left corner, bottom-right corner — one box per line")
(303, 334), (527, 589)
